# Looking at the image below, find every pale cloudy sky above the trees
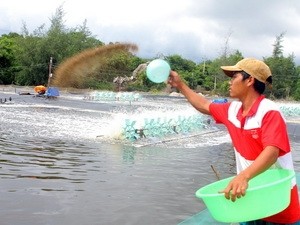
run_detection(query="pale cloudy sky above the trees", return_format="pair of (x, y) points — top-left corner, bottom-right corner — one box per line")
(0, 0), (300, 65)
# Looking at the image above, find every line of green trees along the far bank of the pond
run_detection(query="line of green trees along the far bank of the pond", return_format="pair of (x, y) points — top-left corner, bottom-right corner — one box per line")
(0, 6), (300, 100)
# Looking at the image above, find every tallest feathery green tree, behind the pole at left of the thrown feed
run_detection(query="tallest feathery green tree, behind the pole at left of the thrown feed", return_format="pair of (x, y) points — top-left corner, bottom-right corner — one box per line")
(15, 6), (103, 85)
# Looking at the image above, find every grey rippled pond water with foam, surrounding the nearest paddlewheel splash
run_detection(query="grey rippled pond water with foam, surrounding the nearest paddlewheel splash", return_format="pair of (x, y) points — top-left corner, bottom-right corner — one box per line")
(0, 92), (300, 225)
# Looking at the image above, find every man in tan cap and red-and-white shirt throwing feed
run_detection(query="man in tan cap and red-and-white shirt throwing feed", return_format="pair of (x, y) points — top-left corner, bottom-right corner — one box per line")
(168, 58), (300, 225)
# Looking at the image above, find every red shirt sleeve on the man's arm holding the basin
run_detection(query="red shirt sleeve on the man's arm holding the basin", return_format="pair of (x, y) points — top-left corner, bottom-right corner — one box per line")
(262, 110), (290, 154)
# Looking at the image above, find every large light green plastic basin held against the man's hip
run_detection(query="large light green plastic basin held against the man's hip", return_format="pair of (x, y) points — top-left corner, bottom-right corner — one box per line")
(196, 169), (295, 223)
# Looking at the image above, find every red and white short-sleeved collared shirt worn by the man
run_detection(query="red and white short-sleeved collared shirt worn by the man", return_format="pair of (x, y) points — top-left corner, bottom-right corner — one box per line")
(209, 95), (300, 223)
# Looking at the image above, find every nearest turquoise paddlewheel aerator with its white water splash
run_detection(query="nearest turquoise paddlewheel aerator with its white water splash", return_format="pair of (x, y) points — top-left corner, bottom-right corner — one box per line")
(101, 107), (210, 141)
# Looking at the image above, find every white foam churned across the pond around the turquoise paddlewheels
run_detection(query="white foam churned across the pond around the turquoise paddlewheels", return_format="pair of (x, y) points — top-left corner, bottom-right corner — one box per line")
(0, 96), (300, 145)
